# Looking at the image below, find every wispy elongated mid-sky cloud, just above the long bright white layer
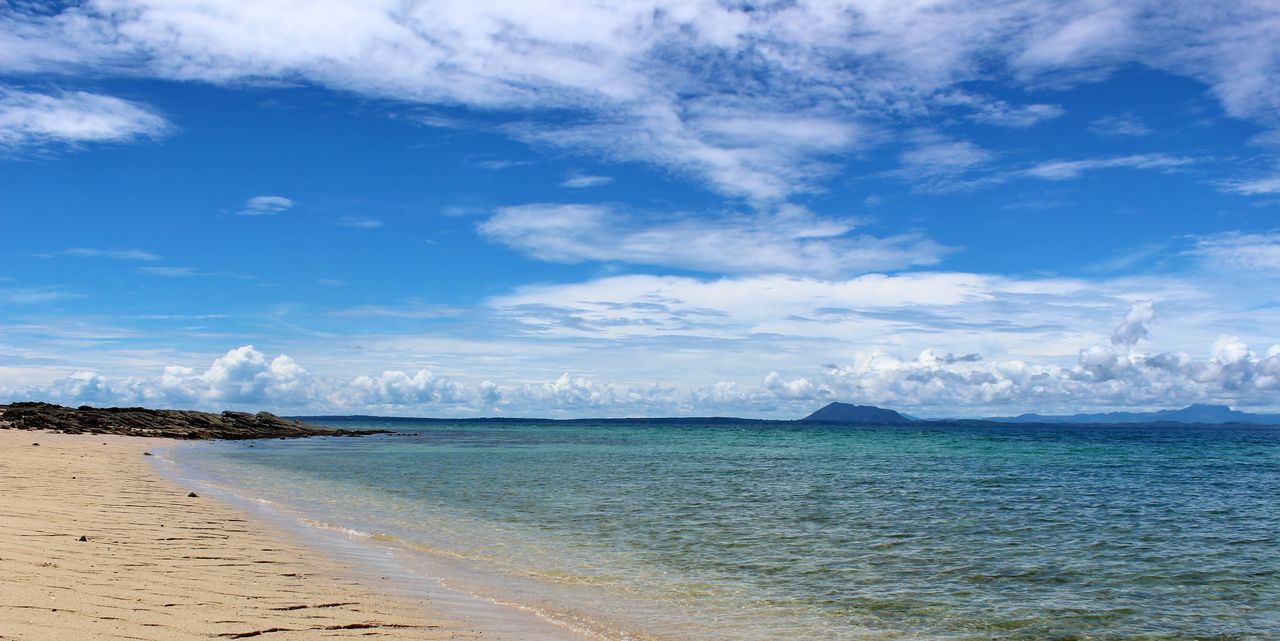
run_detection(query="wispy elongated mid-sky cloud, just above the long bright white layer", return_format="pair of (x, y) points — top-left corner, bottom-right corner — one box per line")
(479, 203), (948, 275)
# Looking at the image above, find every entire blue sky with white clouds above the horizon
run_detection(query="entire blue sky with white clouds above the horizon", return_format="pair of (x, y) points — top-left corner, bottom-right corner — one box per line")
(0, 0), (1280, 418)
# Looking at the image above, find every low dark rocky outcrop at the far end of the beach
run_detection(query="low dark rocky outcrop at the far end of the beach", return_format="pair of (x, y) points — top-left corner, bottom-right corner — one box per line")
(0, 403), (385, 440)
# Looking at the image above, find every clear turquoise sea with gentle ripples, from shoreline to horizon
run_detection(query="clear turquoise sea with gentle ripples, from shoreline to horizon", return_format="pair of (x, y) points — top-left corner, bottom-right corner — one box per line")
(165, 422), (1280, 641)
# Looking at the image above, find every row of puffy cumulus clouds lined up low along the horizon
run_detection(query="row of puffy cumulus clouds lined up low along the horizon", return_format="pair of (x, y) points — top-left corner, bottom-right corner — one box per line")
(17, 324), (1280, 417)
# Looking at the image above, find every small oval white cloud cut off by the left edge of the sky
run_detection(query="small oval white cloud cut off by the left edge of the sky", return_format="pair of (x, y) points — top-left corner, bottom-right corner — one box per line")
(0, 86), (172, 148)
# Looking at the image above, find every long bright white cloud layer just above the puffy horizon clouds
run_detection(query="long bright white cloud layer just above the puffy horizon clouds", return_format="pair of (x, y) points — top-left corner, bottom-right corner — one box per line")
(490, 273), (1208, 360)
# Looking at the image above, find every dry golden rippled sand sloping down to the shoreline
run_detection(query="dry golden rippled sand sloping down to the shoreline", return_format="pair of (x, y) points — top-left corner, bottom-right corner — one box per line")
(0, 430), (480, 641)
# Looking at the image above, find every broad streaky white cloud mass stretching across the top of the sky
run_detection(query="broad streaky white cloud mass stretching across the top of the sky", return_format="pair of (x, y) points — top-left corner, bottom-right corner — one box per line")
(0, 0), (1280, 201)
